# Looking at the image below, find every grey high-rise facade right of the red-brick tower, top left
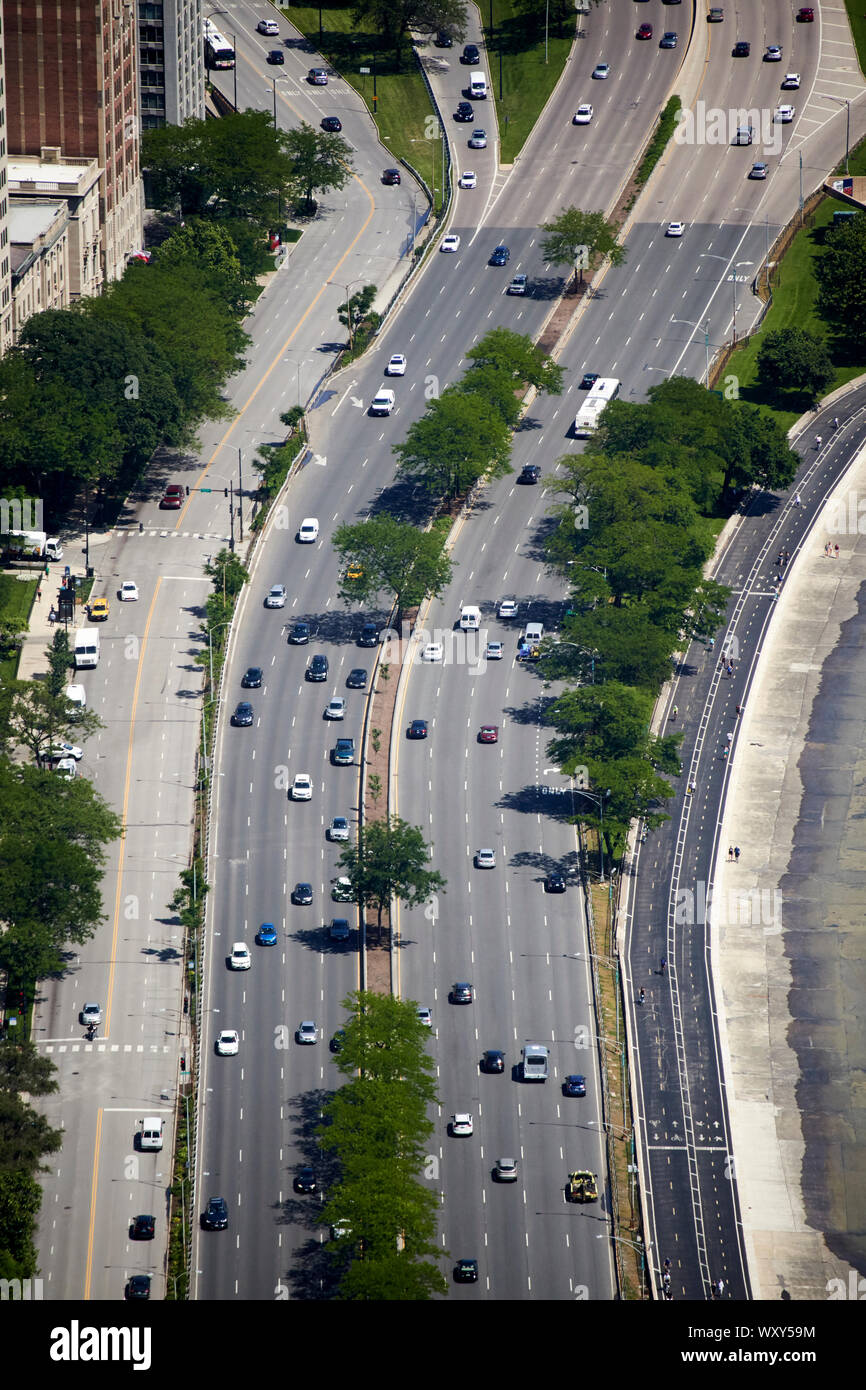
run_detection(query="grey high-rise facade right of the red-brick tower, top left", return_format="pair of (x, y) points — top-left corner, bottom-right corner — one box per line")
(138, 0), (204, 131)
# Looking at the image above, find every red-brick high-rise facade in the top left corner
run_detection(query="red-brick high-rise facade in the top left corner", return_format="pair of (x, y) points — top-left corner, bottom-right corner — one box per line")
(3, 0), (143, 281)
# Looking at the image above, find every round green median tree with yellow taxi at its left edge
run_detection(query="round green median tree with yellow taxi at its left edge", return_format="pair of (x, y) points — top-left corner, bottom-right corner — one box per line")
(332, 516), (452, 623)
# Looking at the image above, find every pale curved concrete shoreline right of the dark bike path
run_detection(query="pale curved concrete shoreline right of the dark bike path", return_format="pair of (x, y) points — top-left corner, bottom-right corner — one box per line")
(712, 439), (866, 1300)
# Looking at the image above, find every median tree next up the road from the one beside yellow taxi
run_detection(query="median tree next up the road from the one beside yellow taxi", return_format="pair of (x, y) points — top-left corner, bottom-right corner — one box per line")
(393, 386), (512, 500)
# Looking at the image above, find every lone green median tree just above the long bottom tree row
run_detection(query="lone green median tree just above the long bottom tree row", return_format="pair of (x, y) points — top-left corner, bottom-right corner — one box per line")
(339, 816), (445, 931)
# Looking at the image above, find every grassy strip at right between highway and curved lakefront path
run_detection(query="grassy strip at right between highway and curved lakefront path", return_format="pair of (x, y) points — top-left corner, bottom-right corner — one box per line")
(717, 136), (866, 430)
